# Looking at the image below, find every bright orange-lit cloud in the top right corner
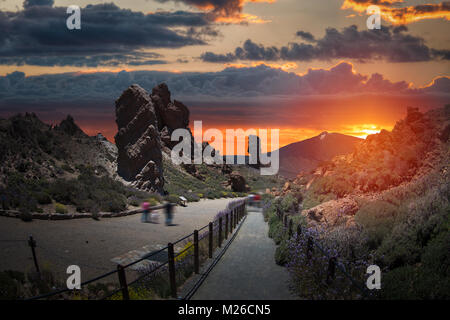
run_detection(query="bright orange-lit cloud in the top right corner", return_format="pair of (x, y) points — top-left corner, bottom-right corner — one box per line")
(342, 0), (450, 25)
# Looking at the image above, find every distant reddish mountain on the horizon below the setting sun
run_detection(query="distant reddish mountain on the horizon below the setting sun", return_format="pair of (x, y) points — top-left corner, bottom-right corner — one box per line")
(279, 132), (362, 178)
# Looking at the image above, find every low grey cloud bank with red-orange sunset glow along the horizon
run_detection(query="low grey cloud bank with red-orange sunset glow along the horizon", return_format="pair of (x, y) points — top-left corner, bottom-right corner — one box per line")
(0, 63), (450, 144)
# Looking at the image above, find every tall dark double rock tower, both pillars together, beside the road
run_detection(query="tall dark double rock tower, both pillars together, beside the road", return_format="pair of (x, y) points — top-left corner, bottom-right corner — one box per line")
(115, 83), (193, 192)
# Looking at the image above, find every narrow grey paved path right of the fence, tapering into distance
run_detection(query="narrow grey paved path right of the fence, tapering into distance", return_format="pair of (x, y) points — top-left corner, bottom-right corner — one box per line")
(192, 211), (296, 300)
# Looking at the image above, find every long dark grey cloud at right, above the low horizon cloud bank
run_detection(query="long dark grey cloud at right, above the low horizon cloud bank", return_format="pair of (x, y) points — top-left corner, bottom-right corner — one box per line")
(201, 25), (449, 63)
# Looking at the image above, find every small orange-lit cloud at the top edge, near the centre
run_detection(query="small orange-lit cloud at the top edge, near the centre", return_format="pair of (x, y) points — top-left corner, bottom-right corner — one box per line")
(156, 0), (276, 23)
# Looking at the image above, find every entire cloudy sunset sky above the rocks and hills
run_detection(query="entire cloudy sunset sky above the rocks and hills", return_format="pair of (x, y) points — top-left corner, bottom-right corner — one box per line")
(0, 0), (450, 155)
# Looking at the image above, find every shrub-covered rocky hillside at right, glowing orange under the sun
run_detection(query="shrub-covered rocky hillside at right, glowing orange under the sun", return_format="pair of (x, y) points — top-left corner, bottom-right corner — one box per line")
(274, 105), (450, 299)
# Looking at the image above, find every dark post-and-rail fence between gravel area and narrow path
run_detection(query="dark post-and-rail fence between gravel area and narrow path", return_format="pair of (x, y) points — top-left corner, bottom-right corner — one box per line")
(25, 200), (246, 300)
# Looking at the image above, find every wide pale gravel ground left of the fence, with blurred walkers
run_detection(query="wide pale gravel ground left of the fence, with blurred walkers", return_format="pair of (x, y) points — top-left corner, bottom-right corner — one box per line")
(0, 199), (232, 281)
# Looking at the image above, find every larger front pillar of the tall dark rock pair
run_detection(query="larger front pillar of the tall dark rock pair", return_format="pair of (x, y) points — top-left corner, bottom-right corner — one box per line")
(115, 85), (164, 192)
